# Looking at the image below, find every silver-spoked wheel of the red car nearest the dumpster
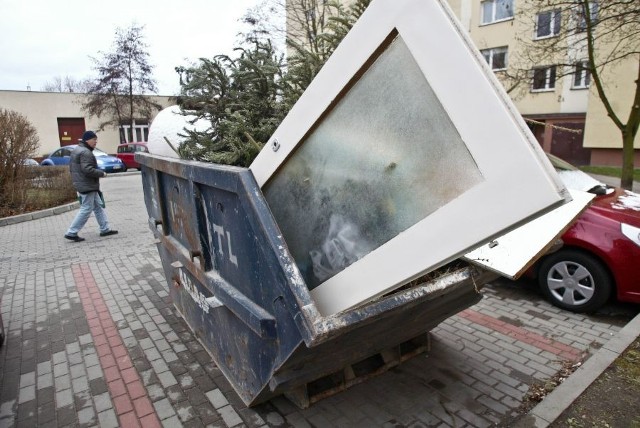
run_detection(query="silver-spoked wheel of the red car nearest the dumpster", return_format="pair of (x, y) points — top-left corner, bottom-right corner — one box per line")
(538, 249), (613, 312)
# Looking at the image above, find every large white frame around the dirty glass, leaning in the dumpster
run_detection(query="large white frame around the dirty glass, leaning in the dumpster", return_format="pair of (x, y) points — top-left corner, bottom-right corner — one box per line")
(250, 0), (570, 316)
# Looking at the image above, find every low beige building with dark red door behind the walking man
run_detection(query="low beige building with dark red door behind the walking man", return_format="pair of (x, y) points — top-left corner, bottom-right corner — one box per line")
(0, 90), (175, 159)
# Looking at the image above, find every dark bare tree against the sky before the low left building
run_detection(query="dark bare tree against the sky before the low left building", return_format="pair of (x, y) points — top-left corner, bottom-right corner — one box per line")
(82, 24), (162, 142)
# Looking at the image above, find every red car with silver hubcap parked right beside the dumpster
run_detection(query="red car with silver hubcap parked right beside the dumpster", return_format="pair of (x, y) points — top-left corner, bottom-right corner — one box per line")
(536, 156), (640, 312)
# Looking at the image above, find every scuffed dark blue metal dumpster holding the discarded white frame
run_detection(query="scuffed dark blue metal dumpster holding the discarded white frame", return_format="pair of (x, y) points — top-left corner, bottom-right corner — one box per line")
(136, 154), (494, 408)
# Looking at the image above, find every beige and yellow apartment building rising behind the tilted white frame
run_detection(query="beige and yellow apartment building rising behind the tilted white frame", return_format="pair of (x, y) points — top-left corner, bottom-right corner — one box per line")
(287, 0), (640, 166)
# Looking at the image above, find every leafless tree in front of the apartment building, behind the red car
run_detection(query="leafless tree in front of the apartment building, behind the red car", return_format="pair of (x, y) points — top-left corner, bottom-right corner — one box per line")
(519, 0), (640, 189)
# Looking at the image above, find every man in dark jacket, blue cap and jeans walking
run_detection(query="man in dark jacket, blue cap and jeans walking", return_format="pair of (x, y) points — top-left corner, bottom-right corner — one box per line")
(64, 131), (118, 242)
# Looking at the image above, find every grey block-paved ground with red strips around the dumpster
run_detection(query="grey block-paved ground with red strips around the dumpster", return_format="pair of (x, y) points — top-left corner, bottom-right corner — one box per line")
(0, 173), (638, 428)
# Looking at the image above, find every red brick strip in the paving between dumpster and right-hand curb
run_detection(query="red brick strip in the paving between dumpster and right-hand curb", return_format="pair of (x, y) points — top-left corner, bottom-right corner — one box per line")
(458, 309), (582, 361)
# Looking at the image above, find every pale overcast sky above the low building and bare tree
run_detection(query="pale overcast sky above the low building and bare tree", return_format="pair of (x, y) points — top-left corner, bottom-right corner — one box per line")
(0, 0), (272, 95)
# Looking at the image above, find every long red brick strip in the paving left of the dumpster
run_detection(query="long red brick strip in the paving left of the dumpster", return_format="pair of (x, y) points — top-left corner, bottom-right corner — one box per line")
(71, 263), (162, 428)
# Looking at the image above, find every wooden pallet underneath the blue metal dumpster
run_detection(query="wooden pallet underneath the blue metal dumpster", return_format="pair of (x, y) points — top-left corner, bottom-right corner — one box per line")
(284, 332), (431, 409)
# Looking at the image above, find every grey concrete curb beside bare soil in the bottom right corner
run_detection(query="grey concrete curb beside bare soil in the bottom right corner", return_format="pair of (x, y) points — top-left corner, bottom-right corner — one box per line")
(515, 314), (640, 428)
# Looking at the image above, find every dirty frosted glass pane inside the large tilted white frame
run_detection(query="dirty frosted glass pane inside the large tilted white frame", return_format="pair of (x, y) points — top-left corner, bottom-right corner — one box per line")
(263, 36), (483, 289)
